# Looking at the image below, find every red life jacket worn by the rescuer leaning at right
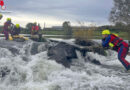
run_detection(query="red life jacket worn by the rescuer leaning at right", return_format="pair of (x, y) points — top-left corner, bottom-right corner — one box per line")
(109, 34), (123, 48)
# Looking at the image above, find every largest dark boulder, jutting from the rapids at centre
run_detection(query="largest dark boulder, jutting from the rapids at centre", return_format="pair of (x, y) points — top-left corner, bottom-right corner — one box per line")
(48, 42), (77, 67)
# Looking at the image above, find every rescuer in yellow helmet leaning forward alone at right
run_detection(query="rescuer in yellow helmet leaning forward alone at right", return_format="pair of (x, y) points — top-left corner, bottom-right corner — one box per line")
(102, 30), (130, 70)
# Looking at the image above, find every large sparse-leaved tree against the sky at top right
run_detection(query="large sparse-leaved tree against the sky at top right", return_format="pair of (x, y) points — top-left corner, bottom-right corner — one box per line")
(109, 0), (130, 25)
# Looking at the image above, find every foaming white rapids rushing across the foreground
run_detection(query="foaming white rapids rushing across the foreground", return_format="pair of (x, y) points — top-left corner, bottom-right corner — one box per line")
(0, 38), (130, 90)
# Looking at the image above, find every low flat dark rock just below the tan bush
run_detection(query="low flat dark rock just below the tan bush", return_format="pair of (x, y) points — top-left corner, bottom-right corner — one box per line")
(75, 39), (94, 46)
